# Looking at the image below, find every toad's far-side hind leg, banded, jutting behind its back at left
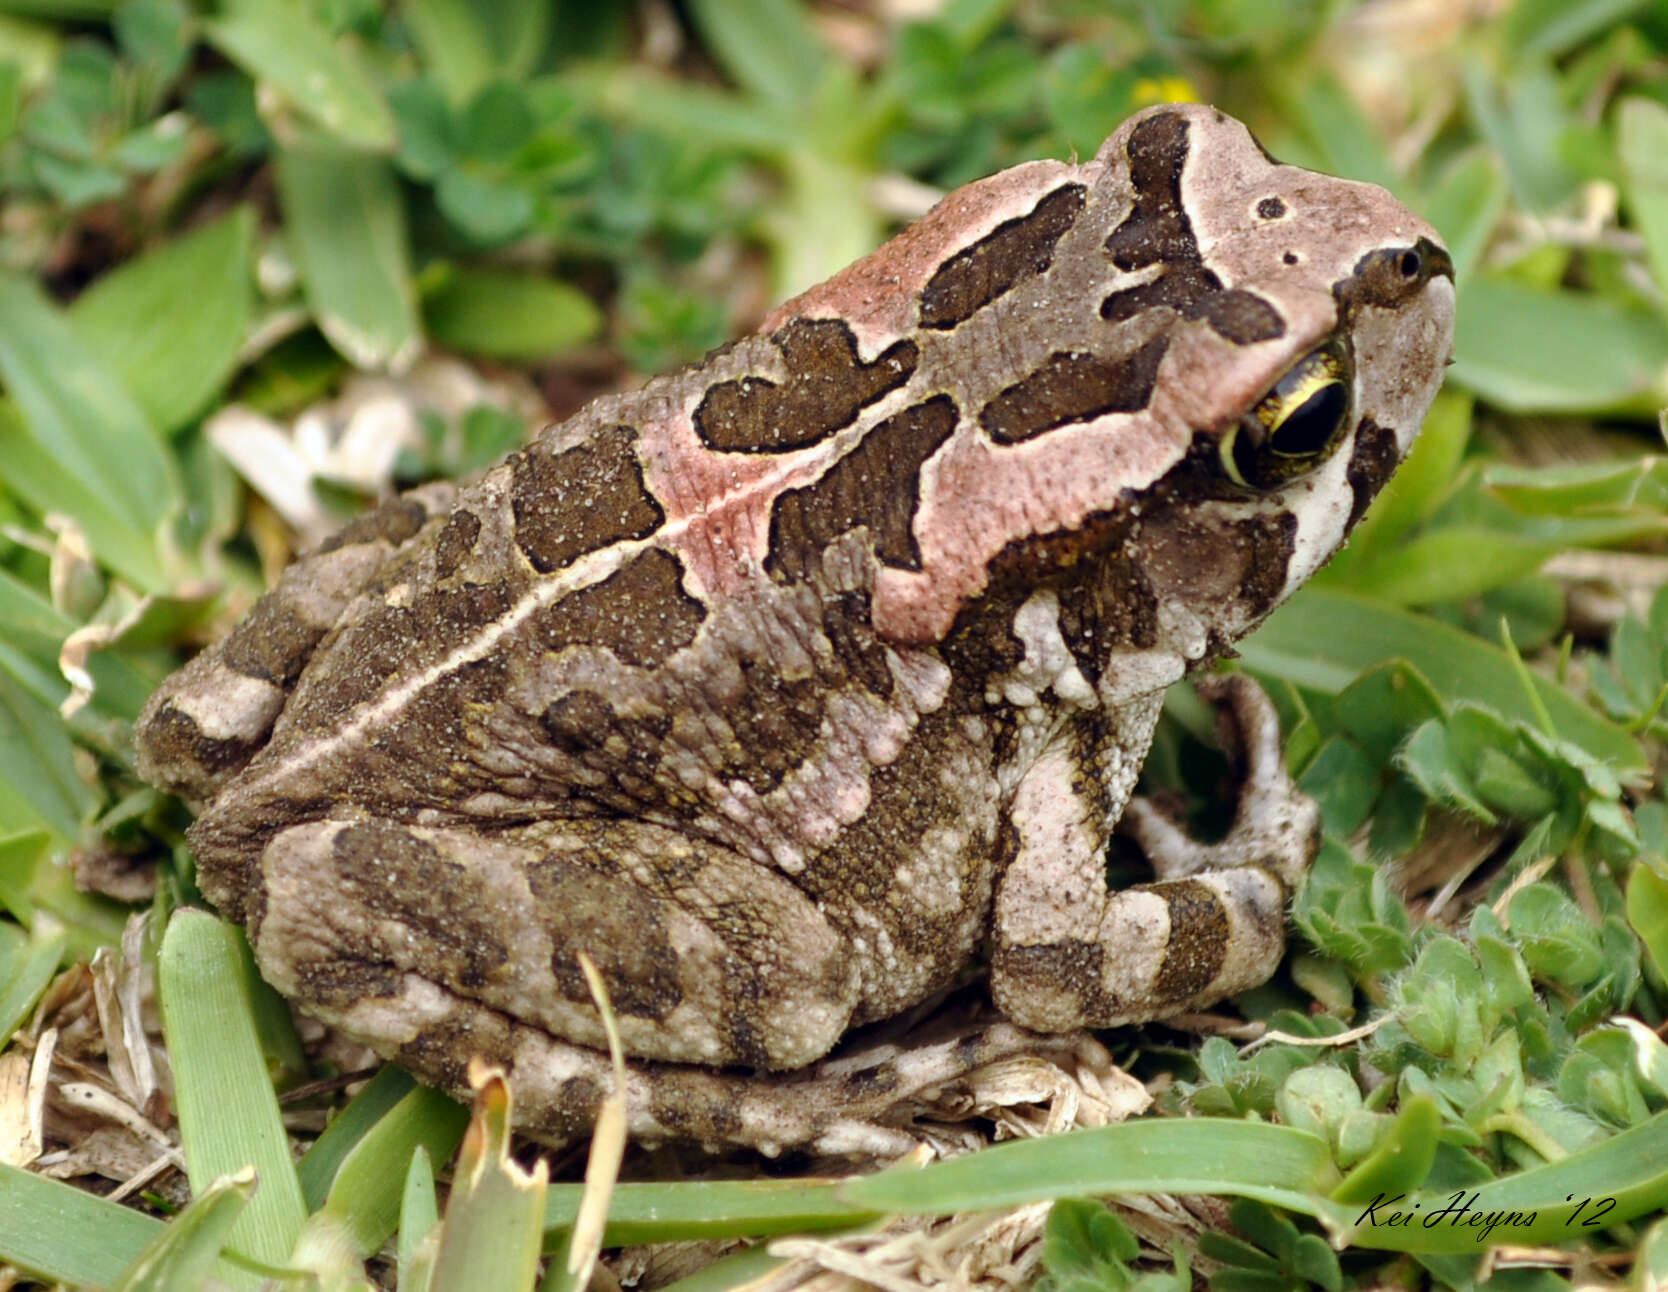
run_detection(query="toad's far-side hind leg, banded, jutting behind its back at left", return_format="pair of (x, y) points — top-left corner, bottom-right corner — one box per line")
(133, 482), (457, 802)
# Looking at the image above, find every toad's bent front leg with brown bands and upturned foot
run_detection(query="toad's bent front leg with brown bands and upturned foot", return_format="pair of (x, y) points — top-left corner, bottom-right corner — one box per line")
(991, 677), (1319, 1032)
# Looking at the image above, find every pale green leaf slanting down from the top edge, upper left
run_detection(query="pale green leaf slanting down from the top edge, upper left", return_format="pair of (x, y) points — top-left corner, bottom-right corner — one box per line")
(203, 0), (395, 152)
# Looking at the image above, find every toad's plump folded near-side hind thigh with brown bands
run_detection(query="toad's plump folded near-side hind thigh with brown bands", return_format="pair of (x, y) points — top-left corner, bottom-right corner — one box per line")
(249, 819), (859, 1089)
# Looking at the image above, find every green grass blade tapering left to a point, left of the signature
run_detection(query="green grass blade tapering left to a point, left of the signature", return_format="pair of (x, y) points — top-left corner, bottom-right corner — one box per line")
(839, 1117), (1338, 1215)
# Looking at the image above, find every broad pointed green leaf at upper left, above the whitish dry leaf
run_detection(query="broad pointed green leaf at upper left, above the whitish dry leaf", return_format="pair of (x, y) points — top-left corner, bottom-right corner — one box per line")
(70, 207), (255, 430)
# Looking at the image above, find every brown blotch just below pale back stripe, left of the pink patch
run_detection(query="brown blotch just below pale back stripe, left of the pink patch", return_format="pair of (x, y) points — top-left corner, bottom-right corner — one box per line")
(534, 547), (707, 669)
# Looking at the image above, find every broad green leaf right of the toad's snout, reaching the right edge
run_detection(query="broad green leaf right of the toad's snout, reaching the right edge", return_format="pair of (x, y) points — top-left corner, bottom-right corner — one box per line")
(1451, 277), (1668, 415)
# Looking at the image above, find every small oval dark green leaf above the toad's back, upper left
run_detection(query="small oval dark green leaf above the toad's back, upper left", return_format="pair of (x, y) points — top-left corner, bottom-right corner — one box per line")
(424, 268), (602, 360)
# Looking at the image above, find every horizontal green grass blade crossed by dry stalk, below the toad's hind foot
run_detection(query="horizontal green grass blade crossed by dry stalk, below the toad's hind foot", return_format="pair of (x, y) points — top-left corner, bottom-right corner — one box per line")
(544, 1179), (879, 1247)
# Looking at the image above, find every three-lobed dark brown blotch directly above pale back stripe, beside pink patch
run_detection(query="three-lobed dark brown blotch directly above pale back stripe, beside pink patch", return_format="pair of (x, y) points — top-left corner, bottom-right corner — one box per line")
(694, 318), (919, 453)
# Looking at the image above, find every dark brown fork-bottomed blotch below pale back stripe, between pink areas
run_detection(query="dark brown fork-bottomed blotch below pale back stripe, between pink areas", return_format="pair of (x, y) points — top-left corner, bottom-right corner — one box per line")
(766, 395), (959, 578)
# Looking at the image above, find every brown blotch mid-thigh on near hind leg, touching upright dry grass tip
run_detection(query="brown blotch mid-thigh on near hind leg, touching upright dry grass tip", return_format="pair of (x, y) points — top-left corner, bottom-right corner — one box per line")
(527, 855), (684, 1022)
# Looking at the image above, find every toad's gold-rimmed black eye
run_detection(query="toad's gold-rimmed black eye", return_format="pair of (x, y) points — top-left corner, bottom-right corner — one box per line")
(1221, 342), (1351, 488)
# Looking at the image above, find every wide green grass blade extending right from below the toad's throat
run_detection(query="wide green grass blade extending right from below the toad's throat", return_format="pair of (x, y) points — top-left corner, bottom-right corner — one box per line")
(1239, 587), (1646, 782)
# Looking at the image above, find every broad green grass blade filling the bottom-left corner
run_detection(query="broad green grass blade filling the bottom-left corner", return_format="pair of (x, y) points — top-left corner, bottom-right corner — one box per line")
(0, 1164), (162, 1287)
